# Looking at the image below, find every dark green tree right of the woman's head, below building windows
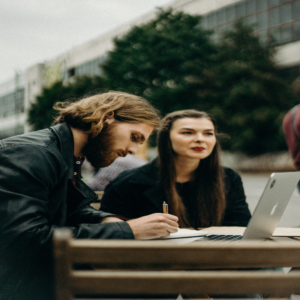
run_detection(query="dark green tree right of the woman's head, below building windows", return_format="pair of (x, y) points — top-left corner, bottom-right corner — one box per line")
(208, 20), (296, 155)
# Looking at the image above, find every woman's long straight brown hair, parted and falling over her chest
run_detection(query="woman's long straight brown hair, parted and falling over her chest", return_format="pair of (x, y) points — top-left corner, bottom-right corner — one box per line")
(157, 110), (226, 228)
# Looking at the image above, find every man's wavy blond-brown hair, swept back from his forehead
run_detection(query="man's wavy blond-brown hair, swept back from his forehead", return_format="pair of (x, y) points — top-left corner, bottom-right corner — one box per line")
(54, 91), (160, 137)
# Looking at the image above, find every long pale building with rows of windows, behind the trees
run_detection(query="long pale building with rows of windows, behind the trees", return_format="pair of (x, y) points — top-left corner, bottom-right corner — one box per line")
(0, 0), (300, 139)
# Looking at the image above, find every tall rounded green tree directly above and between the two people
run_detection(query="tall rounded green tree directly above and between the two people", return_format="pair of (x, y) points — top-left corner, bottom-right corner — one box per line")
(103, 10), (217, 114)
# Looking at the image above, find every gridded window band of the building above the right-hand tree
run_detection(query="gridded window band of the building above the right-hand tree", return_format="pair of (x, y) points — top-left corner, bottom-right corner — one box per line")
(202, 0), (300, 53)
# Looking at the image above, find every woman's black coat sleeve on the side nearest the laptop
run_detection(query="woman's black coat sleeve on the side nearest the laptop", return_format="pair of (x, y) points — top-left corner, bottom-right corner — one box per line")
(222, 168), (251, 226)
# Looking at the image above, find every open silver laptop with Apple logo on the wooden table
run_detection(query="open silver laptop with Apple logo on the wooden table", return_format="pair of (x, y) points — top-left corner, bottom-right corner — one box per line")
(199, 172), (300, 241)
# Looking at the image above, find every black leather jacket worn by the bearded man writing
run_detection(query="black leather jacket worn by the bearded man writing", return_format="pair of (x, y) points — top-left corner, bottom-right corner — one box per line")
(0, 123), (134, 300)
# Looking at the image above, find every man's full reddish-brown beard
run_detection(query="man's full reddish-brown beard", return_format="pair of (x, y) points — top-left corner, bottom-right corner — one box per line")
(82, 123), (126, 169)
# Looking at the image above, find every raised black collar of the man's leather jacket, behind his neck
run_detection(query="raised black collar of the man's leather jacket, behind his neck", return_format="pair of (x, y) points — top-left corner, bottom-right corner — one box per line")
(51, 123), (74, 179)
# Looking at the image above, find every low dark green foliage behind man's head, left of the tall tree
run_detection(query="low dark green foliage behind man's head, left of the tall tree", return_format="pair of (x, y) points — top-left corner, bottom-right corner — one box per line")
(28, 77), (103, 130)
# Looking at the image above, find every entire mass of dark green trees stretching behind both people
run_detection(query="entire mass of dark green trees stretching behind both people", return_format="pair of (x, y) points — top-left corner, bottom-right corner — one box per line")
(29, 10), (297, 155)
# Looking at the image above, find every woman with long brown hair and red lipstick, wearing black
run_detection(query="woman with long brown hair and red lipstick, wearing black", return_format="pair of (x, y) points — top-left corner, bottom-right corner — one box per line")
(101, 110), (251, 228)
